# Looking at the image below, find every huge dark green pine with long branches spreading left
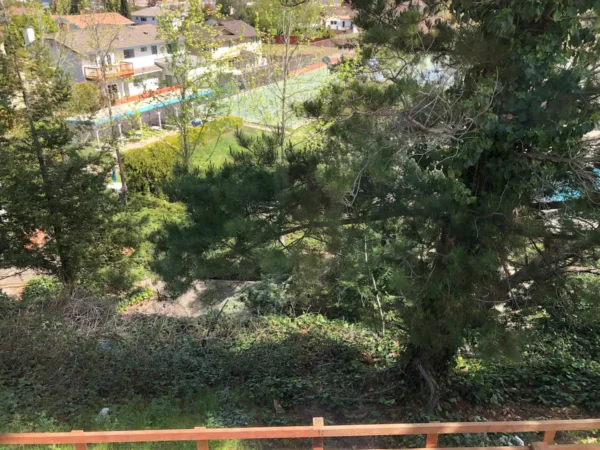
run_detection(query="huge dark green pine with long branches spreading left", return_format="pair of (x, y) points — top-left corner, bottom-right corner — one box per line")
(160, 0), (600, 407)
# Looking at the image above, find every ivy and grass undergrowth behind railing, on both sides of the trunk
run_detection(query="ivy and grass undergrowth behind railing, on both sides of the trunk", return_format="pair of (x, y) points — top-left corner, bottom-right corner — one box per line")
(0, 299), (600, 449)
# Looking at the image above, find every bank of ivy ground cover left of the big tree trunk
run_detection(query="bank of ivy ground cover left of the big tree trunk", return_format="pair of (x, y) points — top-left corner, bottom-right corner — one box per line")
(0, 299), (398, 426)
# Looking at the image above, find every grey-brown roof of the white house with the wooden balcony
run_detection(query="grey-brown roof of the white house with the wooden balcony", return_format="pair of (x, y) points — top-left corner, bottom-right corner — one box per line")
(49, 25), (165, 54)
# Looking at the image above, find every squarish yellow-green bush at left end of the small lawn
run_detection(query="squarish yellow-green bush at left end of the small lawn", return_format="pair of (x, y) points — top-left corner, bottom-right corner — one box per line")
(123, 144), (177, 196)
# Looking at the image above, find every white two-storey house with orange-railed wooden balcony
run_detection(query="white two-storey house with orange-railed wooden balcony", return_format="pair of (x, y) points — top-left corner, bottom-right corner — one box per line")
(47, 25), (179, 100)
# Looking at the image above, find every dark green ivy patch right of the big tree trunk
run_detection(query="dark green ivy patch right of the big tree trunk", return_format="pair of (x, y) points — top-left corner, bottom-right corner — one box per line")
(451, 325), (600, 411)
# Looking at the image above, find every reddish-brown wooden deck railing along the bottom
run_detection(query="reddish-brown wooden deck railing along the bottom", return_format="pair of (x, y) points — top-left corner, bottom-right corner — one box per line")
(0, 417), (600, 450)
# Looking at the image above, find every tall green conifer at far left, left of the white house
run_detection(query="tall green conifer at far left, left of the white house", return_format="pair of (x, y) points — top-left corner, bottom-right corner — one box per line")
(0, 1), (132, 286)
